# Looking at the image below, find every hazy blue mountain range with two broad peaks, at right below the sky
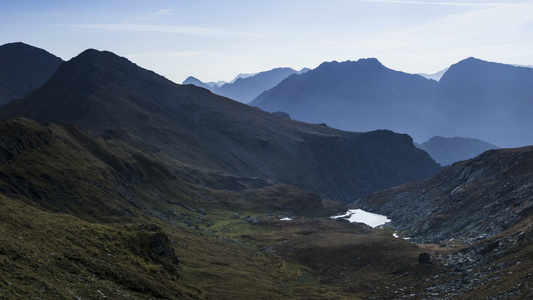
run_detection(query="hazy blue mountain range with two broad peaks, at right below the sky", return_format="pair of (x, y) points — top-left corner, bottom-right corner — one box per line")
(250, 58), (533, 147)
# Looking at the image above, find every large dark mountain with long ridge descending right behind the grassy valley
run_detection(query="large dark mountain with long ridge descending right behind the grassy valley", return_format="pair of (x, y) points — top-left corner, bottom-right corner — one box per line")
(0, 50), (438, 202)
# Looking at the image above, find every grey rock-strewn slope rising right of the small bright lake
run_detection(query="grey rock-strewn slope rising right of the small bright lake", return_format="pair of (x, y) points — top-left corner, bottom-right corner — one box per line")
(354, 147), (533, 243)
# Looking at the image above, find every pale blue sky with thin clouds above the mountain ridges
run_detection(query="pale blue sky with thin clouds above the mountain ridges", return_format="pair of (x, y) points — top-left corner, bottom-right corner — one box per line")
(0, 0), (533, 83)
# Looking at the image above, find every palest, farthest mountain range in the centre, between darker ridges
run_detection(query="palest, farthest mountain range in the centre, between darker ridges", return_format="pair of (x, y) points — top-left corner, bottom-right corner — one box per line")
(183, 68), (309, 103)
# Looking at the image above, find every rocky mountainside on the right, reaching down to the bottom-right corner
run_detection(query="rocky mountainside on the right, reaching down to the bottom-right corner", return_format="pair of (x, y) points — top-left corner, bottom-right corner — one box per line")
(354, 147), (533, 299)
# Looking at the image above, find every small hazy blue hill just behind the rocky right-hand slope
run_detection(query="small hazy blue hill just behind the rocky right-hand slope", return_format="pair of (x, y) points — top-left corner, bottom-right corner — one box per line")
(419, 136), (500, 166)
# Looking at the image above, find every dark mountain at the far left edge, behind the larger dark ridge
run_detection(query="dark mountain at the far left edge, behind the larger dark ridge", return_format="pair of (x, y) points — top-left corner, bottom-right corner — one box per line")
(0, 43), (63, 106)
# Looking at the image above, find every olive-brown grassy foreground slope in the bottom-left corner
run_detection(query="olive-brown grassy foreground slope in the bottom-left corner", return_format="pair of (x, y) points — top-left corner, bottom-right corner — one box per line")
(0, 196), (205, 299)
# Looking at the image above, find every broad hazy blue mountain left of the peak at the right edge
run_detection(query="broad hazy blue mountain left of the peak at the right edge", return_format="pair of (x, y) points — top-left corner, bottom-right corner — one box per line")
(250, 58), (438, 135)
